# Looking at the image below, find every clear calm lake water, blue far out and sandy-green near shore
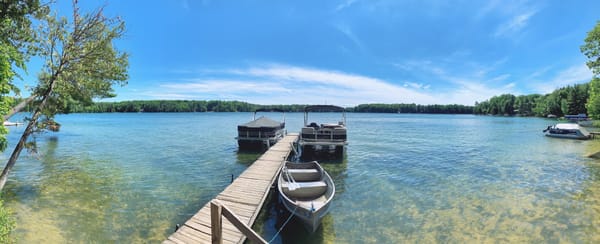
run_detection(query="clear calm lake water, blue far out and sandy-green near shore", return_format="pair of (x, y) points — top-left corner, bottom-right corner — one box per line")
(1, 113), (600, 243)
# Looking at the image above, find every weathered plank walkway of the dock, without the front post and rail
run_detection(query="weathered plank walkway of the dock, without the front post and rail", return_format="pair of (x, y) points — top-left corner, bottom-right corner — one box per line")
(163, 133), (298, 244)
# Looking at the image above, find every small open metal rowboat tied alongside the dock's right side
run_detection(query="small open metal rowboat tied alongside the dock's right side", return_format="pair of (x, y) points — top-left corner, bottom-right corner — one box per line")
(277, 161), (335, 233)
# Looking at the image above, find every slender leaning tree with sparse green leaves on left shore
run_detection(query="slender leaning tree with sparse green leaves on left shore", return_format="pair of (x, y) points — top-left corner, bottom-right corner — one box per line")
(0, 1), (128, 193)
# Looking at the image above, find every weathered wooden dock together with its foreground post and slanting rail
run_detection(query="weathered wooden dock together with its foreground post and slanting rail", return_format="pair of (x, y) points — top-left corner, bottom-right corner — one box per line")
(163, 133), (299, 244)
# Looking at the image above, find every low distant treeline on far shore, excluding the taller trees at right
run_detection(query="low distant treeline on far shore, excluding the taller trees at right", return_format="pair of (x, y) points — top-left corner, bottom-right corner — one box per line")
(59, 100), (473, 114)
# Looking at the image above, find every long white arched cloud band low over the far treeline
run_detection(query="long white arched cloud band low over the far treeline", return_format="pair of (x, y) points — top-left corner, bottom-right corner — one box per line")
(149, 64), (443, 106)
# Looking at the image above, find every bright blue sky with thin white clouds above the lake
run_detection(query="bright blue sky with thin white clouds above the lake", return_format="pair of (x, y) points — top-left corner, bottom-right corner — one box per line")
(24, 0), (600, 106)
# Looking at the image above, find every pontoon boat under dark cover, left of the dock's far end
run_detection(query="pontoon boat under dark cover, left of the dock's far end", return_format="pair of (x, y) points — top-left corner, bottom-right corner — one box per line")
(235, 109), (286, 149)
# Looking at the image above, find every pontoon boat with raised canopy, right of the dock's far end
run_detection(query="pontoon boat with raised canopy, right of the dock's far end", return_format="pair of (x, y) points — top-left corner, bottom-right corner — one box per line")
(298, 105), (348, 155)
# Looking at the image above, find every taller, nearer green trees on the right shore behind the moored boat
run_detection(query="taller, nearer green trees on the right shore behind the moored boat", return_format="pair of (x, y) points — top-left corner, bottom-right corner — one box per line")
(474, 83), (589, 117)
